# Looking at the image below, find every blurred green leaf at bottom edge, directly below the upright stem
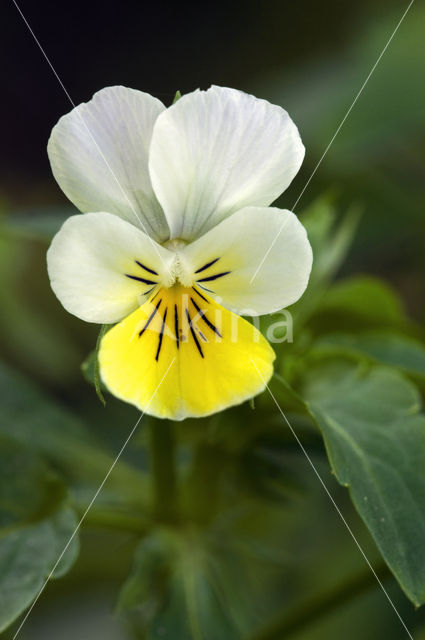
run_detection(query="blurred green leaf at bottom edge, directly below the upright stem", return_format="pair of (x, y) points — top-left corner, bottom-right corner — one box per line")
(119, 530), (240, 640)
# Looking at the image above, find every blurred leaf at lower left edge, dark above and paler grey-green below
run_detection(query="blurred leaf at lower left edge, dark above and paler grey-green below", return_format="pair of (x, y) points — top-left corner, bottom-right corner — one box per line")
(0, 438), (78, 631)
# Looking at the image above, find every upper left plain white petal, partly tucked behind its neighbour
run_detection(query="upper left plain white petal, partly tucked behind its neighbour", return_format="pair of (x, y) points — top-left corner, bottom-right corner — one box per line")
(47, 87), (169, 242)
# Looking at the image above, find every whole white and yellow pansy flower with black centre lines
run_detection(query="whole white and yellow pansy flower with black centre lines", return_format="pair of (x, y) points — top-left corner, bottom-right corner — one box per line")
(48, 87), (312, 420)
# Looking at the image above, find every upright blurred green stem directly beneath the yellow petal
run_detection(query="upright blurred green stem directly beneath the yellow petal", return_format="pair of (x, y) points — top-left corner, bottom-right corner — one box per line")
(150, 420), (177, 522)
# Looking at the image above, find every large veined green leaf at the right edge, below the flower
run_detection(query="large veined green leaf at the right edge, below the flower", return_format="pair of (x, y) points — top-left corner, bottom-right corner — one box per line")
(304, 361), (425, 605)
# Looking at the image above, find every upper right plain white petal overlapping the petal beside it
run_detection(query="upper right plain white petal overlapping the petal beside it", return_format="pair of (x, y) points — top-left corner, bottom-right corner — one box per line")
(149, 87), (304, 240)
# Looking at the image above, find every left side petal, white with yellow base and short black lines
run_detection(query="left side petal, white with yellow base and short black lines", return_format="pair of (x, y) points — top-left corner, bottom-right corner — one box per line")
(47, 212), (175, 324)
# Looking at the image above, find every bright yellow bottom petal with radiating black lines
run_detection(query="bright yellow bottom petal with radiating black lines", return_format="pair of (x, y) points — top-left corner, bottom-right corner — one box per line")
(99, 285), (275, 420)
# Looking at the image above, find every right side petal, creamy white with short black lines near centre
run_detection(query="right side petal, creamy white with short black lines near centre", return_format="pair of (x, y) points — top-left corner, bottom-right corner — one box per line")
(181, 207), (312, 316)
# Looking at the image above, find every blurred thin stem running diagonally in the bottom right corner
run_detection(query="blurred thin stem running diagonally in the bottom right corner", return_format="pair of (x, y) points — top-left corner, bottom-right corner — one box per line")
(250, 562), (391, 640)
